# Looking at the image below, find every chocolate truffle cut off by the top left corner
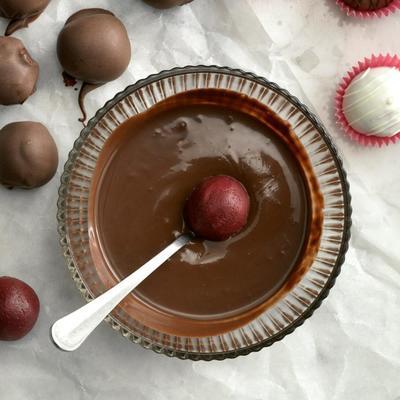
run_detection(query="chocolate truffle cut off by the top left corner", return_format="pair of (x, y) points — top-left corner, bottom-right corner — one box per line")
(0, 0), (50, 36)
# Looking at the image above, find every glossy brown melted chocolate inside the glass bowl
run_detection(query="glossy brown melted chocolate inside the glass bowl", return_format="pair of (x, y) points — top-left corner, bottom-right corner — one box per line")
(90, 90), (321, 336)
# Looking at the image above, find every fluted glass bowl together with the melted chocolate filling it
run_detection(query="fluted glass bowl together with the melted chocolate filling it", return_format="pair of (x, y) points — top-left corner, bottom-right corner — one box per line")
(58, 67), (350, 359)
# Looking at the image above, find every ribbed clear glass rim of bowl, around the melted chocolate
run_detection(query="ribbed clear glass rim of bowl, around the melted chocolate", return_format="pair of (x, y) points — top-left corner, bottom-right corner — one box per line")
(57, 66), (351, 360)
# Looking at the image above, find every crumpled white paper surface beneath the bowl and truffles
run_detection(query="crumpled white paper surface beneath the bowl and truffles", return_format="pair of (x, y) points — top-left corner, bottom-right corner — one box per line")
(0, 0), (400, 400)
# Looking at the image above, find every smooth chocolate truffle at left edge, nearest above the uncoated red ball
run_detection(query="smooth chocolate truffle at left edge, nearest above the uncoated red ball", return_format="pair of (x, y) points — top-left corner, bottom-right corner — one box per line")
(0, 121), (58, 189)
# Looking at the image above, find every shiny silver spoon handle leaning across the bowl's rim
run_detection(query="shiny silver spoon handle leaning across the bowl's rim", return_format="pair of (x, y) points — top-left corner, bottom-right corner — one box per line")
(51, 235), (191, 351)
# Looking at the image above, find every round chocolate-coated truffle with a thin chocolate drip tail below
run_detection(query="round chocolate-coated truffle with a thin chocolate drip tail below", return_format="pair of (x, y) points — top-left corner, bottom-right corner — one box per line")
(57, 8), (131, 121)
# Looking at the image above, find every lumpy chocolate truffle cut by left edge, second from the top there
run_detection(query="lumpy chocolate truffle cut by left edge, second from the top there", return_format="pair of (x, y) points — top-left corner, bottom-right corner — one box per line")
(0, 37), (39, 105)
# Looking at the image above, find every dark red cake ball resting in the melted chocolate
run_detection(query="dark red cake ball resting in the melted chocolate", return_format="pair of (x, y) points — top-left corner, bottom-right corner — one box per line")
(184, 175), (250, 241)
